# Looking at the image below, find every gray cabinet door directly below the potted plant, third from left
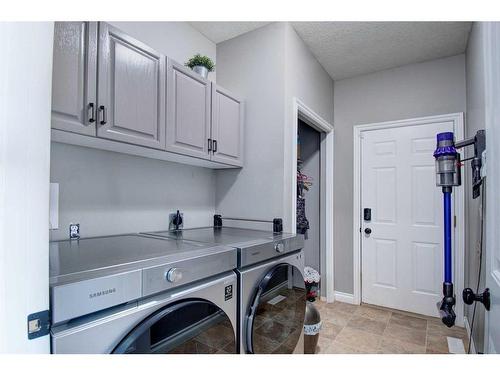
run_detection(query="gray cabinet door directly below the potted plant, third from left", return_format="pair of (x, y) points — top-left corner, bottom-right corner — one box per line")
(166, 60), (211, 159)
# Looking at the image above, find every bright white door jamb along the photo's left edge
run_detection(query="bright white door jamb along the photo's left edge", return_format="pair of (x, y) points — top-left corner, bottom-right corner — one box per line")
(0, 22), (54, 353)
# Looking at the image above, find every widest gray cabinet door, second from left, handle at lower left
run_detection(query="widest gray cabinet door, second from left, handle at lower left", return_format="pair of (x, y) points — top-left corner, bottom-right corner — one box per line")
(97, 22), (166, 149)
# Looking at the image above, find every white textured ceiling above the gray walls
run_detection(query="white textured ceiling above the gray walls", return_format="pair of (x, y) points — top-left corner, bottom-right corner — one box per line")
(191, 22), (471, 80)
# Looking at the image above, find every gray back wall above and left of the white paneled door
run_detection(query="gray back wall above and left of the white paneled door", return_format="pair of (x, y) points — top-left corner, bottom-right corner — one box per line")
(334, 55), (465, 293)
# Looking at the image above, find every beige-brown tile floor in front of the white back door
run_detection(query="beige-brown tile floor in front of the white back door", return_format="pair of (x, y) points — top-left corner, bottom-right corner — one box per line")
(315, 301), (468, 354)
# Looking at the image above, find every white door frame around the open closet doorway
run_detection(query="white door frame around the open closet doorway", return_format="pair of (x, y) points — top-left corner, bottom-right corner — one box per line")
(292, 98), (335, 302)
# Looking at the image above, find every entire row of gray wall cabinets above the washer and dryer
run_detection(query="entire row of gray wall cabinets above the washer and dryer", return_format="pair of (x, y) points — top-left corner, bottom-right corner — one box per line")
(52, 22), (244, 168)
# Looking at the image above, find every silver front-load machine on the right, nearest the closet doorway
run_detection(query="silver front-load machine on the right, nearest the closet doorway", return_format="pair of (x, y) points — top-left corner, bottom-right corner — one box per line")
(148, 223), (306, 354)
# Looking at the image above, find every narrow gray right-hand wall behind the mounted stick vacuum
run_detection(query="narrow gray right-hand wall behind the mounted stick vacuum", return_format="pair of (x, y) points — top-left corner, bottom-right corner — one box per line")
(462, 22), (486, 352)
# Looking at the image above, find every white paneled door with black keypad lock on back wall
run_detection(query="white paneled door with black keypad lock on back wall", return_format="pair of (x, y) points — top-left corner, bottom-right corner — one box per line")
(360, 120), (455, 316)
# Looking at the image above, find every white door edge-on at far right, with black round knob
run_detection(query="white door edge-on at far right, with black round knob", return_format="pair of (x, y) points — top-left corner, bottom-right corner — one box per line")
(485, 22), (500, 353)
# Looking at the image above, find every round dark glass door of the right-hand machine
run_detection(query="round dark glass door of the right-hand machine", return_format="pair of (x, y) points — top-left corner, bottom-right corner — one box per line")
(246, 264), (306, 354)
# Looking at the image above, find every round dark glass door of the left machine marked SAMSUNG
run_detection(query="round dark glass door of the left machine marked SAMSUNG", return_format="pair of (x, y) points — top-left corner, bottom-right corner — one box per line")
(113, 299), (236, 354)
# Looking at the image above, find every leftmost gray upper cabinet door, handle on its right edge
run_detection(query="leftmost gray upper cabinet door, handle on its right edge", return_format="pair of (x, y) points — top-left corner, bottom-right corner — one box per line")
(52, 22), (97, 135)
